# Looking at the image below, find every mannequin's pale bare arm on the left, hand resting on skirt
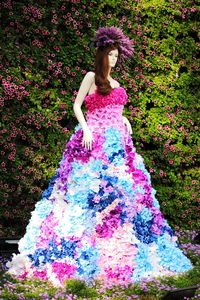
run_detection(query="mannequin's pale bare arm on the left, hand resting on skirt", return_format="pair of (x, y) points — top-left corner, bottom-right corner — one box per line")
(73, 72), (95, 150)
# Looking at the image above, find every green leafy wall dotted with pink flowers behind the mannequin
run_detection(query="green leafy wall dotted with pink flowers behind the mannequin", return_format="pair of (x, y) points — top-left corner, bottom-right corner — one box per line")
(0, 0), (199, 236)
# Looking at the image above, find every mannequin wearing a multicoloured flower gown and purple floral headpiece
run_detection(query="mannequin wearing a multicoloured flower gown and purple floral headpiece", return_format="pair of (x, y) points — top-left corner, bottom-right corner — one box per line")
(7, 27), (192, 286)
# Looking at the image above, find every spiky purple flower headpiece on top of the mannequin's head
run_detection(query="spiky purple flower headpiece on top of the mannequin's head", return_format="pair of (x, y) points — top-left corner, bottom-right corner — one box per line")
(92, 26), (134, 60)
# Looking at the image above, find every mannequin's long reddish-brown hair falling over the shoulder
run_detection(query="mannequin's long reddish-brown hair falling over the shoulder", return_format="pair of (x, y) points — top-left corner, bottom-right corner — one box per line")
(95, 44), (121, 95)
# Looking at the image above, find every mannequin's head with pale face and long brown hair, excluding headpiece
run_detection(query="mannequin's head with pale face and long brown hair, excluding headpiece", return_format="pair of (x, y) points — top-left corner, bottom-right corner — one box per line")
(95, 44), (121, 94)
